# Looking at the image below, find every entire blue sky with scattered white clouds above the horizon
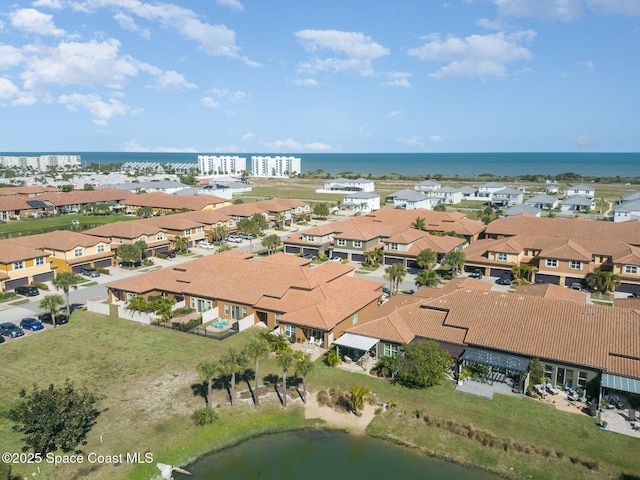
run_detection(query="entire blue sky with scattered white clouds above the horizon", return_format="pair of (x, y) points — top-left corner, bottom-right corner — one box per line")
(0, 0), (640, 153)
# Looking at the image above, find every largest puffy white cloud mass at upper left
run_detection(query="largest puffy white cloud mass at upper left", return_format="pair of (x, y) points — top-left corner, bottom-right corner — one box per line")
(20, 39), (139, 90)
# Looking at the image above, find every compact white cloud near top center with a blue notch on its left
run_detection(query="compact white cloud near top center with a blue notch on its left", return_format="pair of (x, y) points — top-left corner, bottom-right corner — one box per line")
(295, 30), (389, 75)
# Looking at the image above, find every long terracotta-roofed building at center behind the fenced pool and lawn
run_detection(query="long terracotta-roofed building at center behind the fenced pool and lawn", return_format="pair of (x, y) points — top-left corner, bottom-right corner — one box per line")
(108, 251), (383, 348)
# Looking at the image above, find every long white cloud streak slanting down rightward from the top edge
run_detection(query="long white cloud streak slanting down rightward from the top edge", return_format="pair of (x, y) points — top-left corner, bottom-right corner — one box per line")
(73, 0), (258, 66)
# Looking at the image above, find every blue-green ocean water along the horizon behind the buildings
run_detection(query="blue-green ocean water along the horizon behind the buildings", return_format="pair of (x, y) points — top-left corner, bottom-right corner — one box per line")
(0, 152), (640, 177)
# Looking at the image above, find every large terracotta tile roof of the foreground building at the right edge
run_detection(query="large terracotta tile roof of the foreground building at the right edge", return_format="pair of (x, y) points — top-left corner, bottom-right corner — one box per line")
(425, 290), (640, 378)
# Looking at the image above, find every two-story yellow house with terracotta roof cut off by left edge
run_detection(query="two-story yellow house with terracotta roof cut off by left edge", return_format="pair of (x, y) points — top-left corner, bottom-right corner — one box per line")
(0, 240), (54, 292)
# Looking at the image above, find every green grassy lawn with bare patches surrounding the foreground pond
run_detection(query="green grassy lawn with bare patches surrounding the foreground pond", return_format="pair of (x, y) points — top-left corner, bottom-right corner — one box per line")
(0, 312), (640, 480)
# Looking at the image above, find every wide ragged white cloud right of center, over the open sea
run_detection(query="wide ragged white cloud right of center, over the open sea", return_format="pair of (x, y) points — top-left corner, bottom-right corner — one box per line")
(408, 30), (536, 78)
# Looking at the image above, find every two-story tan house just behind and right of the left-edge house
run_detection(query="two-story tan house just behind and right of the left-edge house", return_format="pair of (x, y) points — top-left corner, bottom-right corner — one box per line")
(5, 230), (114, 274)
